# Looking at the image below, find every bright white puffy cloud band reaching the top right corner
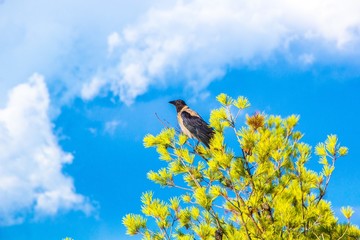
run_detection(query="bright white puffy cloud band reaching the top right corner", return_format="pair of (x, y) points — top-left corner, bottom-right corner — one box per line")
(82, 0), (360, 104)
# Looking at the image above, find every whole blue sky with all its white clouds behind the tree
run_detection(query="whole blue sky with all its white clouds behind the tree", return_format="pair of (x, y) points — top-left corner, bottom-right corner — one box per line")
(0, 0), (360, 240)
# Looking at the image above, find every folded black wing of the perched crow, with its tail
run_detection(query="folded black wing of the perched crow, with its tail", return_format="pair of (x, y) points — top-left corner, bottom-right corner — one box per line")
(181, 111), (214, 147)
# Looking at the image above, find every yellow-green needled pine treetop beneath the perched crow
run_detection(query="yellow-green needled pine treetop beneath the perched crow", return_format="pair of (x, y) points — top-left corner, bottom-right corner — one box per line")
(123, 94), (360, 240)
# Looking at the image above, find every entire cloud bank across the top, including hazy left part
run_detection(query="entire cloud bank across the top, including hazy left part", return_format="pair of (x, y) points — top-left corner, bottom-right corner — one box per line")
(0, 0), (360, 107)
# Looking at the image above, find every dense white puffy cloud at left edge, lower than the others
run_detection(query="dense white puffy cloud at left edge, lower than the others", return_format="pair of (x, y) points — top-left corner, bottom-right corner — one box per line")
(0, 74), (92, 225)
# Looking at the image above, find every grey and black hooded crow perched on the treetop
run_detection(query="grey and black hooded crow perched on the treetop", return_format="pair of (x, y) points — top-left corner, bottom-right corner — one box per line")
(169, 99), (214, 148)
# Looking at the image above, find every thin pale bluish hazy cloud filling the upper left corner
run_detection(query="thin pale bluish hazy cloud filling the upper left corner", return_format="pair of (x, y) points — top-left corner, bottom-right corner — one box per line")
(0, 0), (165, 107)
